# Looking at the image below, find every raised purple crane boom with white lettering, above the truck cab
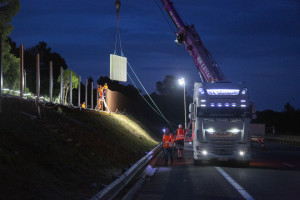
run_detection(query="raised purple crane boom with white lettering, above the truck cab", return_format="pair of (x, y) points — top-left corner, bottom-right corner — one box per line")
(161, 0), (226, 82)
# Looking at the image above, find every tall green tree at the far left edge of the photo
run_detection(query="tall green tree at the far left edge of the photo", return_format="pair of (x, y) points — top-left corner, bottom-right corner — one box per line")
(0, 0), (20, 89)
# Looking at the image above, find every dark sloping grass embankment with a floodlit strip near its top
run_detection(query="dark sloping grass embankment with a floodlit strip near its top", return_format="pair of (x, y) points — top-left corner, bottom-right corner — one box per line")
(0, 97), (157, 199)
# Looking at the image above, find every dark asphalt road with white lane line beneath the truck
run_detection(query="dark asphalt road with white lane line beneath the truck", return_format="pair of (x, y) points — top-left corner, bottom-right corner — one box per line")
(136, 142), (300, 200)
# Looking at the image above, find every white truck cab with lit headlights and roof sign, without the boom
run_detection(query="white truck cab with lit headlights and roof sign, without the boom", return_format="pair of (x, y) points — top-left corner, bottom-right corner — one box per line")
(189, 82), (251, 164)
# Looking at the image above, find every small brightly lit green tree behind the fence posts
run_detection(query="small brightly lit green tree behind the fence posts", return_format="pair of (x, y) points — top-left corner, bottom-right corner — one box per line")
(57, 70), (79, 104)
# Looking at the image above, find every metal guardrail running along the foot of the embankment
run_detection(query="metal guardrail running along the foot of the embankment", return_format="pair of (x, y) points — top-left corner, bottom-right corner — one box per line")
(90, 144), (161, 200)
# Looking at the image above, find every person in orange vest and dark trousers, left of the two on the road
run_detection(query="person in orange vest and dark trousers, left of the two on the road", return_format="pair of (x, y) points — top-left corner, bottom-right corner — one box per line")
(163, 128), (174, 166)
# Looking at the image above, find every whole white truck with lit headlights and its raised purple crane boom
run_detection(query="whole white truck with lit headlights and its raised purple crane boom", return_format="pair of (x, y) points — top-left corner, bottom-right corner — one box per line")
(161, 0), (255, 165)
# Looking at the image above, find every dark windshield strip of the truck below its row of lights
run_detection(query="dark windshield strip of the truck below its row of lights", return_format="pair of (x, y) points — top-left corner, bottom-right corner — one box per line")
(197, 107), (249, 118)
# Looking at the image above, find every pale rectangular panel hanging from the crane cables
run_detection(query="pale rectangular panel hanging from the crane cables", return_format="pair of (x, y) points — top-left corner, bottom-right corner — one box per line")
(110, 54), (127, 82)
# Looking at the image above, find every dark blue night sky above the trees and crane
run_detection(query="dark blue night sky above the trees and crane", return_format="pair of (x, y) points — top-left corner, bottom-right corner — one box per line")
(11, 0), (300, 111)
